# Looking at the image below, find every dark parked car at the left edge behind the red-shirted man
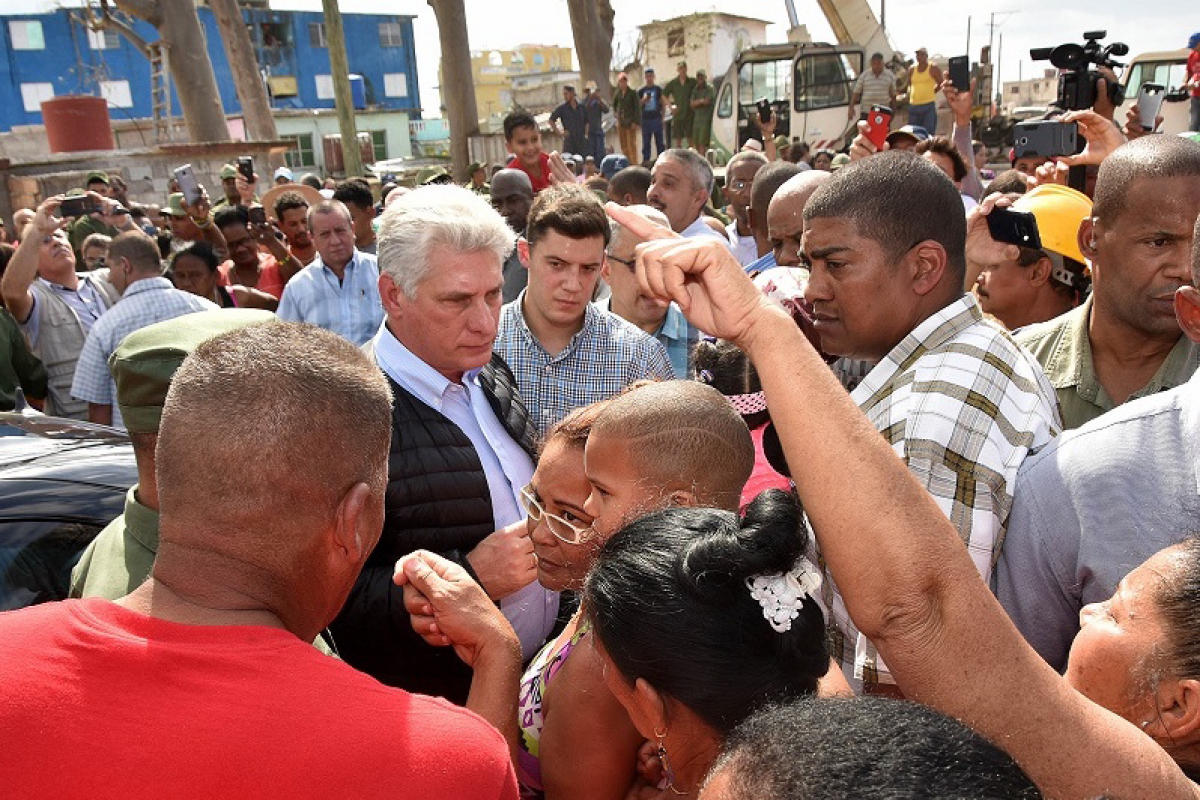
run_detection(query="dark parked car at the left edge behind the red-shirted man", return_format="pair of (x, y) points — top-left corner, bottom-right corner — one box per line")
(0, 413), (138, 610)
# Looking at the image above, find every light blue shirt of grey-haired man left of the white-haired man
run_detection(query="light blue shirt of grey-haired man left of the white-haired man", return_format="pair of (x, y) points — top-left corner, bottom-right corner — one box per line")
(277, 249), (383, 344)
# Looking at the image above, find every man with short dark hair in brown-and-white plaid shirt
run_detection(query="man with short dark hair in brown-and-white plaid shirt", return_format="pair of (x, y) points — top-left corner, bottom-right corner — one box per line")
(804, 152), (1062, 693)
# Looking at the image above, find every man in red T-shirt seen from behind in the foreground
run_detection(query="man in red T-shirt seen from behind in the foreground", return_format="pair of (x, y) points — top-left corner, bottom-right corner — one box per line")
(0, 321), (521, 800)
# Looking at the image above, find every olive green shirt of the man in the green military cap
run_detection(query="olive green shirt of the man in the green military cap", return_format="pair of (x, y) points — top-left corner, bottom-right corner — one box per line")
(68, 486), (336, 657)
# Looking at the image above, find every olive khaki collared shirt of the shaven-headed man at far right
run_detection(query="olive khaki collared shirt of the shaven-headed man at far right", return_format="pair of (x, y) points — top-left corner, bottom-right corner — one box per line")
(1015, 297), (1200, 431)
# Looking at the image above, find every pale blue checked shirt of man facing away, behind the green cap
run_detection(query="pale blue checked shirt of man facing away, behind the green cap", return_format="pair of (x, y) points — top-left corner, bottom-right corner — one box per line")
(71, 278), (217, 428)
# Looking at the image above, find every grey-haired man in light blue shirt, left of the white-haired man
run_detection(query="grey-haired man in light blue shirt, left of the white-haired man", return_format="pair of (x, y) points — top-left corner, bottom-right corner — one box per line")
(277, 200), (383, 344)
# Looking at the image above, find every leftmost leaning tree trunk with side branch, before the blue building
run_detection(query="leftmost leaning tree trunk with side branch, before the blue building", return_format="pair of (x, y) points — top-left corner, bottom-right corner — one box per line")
(115, 0), (229, 142)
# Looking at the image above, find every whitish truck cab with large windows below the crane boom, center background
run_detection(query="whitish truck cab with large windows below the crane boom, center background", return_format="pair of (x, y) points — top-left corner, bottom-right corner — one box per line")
(713, 42), (865, 162)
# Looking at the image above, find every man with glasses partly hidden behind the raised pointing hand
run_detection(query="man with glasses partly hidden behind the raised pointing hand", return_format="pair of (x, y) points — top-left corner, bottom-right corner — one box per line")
(596, 205), (697, 379)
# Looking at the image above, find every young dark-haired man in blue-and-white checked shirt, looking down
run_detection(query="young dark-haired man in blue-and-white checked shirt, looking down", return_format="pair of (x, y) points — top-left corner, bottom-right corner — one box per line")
(494, 184), (674, 435)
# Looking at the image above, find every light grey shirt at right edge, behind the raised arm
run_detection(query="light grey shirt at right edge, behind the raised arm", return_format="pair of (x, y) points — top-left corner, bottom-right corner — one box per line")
(994, 373), (1200, 670)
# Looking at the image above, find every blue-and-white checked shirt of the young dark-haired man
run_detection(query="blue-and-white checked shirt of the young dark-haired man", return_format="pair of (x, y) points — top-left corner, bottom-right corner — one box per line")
(493, 291), (674, 435)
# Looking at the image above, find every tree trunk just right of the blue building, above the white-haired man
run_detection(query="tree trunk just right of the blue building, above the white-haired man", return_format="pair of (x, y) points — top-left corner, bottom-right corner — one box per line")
(428, 0), (479, 184)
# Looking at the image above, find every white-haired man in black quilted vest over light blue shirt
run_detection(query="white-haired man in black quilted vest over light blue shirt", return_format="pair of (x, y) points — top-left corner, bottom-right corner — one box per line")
(331, 186), (558, 703)
